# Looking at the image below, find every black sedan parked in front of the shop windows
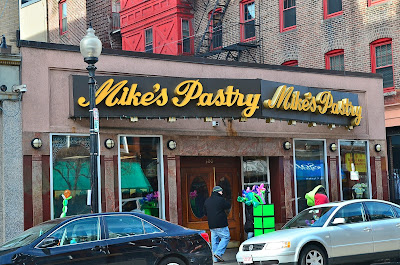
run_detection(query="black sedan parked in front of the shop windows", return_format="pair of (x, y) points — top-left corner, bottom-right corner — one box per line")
(0, 212), (213, 265)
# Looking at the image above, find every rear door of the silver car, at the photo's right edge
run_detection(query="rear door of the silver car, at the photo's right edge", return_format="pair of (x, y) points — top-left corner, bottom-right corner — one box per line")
(364, 201), (400, 258)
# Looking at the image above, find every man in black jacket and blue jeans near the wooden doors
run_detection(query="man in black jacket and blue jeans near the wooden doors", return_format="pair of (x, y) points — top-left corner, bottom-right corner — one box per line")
(204, 186), (231, 262)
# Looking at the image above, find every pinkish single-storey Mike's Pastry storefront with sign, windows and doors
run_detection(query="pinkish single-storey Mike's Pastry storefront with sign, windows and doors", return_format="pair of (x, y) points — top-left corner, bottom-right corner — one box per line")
(21, 42), (388, 242)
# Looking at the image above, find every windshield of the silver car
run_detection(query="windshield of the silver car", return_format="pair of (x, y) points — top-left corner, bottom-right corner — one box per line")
(283, 206), (336, 229)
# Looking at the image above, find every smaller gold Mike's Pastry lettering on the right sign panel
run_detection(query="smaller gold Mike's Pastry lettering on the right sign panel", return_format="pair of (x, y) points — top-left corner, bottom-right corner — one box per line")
(263, 85), (362, 126)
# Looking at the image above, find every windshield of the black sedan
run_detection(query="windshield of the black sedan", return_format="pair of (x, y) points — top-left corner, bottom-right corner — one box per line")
(0, 221), (58, 250)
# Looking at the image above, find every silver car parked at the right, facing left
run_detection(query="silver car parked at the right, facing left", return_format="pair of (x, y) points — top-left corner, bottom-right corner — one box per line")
(236, 199), (400, 265)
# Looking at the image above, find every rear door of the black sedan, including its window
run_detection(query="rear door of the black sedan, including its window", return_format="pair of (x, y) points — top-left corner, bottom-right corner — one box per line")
(104, 214), (167, 265)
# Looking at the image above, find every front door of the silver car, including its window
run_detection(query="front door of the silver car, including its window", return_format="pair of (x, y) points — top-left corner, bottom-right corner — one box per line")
(330, 203), (374, 262)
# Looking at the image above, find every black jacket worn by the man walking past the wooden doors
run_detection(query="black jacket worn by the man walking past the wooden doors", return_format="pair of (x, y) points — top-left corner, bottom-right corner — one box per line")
(204, 192), (231, 229)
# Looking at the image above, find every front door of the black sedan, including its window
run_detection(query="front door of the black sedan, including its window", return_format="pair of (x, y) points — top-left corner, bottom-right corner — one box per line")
(33, 217), (107, 265)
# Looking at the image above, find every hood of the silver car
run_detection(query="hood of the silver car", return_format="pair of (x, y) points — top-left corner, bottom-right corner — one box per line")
(243, 227), (326, 244)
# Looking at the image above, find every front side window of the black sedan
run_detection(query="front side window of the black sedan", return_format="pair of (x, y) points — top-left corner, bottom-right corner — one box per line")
(50, 217), (101, 246)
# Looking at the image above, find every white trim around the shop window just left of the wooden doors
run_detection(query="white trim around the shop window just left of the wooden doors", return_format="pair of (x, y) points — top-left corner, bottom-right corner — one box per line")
(118, 134), (165, 219)
